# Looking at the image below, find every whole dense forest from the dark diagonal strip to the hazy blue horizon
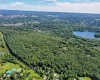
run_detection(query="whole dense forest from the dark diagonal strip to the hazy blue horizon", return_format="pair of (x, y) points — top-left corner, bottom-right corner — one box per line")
(0, 10), (100, 80)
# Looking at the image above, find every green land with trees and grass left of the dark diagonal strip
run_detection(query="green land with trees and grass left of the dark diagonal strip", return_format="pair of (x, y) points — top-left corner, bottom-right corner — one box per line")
(0, 33), (43, 80)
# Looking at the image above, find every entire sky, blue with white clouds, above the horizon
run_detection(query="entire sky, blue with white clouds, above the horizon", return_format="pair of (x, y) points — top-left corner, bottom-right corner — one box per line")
(0, 0), (100, 14)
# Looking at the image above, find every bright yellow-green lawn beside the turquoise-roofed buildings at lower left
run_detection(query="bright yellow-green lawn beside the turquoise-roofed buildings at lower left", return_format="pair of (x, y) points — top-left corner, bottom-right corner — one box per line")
(0, 62), (43, 80)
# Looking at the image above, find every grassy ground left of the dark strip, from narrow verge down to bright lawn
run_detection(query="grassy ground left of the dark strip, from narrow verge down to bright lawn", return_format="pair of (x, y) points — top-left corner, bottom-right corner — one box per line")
(0, 32), (43, 80)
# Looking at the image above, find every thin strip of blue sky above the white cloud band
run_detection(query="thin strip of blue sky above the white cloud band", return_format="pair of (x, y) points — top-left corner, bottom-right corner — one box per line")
(0, 0), (100, 5)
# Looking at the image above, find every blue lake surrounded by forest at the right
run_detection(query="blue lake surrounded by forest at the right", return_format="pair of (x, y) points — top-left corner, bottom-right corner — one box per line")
(73, 31), (96, 39)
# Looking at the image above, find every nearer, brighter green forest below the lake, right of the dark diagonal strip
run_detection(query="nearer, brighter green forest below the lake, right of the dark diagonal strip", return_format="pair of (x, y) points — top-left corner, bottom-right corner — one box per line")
(3, 30), (100, 79)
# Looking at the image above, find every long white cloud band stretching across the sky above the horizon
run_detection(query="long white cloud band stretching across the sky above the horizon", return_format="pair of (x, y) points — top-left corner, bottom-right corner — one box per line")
(0, 0), (100, 14)
